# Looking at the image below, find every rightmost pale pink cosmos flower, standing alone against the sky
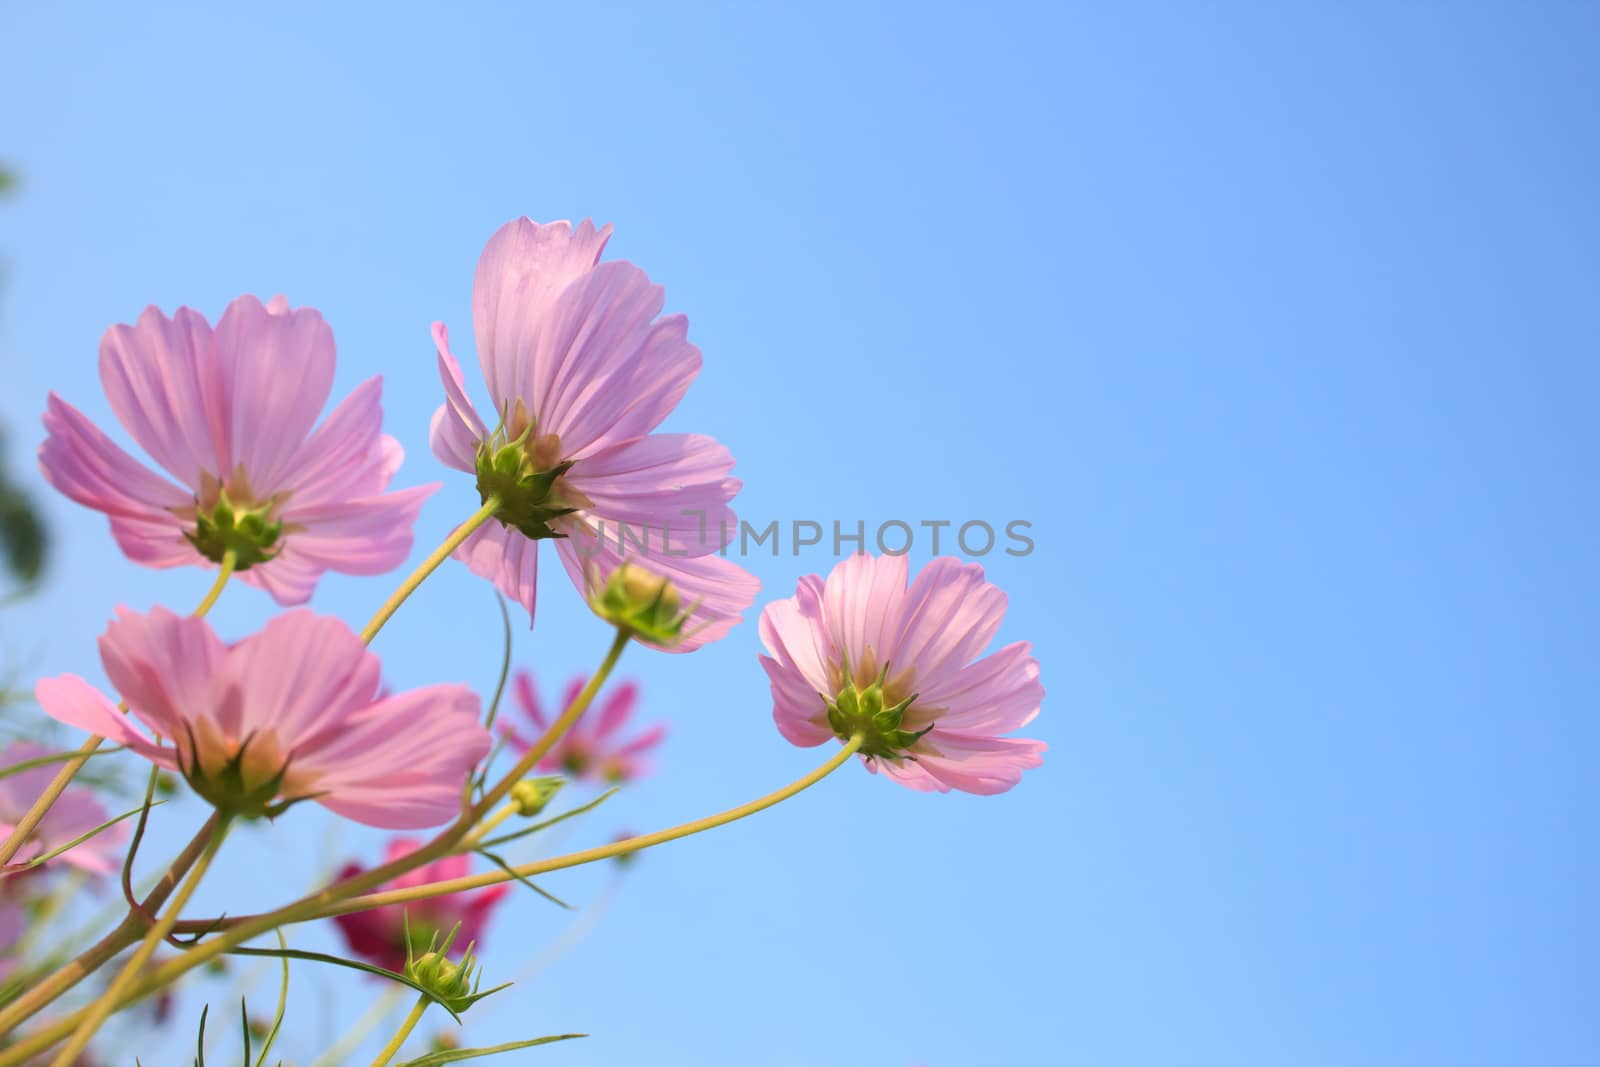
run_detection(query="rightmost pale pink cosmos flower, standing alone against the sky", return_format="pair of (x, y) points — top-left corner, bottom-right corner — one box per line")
(762, 555), (1045, 793)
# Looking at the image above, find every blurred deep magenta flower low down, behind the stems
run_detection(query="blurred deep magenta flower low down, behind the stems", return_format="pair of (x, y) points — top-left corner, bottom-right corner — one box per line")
(324, 837), (510, 971)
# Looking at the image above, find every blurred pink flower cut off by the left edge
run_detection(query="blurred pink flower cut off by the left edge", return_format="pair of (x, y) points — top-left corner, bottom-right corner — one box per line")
(0, 741), (128, 875)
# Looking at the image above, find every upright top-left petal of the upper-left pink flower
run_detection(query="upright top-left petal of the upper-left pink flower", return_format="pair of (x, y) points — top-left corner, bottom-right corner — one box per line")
(99, 307), (230, 490)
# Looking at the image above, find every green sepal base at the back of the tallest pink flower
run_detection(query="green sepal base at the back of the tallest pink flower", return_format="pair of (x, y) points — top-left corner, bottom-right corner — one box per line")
(477, 400), (586, 541)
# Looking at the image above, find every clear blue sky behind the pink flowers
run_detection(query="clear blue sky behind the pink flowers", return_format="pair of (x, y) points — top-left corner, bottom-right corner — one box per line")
(0, 3), (1600, 1067)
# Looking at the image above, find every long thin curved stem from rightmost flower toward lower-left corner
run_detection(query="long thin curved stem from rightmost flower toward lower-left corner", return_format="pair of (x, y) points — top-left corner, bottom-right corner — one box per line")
(0, 736), (862, 1067)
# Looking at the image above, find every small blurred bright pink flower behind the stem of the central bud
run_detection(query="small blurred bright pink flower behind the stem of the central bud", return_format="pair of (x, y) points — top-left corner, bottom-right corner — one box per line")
(506, 670), (667, 784)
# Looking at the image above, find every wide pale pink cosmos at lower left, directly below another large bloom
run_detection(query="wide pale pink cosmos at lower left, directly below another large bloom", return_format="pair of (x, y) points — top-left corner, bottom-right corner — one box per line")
(35, 608), (490, 829)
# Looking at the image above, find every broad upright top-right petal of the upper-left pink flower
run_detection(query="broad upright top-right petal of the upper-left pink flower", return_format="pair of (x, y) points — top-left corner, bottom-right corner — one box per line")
(216, 296), (334, 496)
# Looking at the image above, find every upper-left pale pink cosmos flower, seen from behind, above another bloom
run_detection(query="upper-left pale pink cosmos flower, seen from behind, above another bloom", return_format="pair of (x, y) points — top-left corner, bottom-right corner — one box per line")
(38, 296), (438, 605)
